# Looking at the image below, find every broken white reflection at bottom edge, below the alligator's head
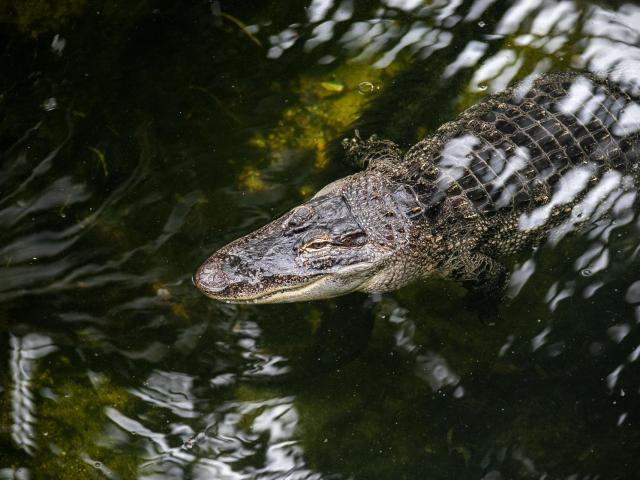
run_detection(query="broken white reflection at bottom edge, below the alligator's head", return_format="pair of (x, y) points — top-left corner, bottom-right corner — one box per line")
(138, 397), (321, 479)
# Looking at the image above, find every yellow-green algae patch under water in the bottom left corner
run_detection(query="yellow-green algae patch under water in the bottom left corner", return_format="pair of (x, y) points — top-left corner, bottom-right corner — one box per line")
(0, 356), (139, 479)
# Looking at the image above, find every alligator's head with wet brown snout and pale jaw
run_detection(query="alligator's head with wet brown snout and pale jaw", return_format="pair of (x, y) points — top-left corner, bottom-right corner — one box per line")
(195, 171), (421, 303)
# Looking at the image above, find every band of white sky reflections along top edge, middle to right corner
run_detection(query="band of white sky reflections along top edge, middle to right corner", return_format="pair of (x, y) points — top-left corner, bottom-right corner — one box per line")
(269, 0), (640, 105)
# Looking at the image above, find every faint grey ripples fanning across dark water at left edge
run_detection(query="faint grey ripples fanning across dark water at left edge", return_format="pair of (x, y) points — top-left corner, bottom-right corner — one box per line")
(0, 123), (156, 301)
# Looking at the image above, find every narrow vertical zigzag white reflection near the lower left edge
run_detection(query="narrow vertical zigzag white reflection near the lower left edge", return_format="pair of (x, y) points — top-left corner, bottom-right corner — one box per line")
(9, 333), (58, 455)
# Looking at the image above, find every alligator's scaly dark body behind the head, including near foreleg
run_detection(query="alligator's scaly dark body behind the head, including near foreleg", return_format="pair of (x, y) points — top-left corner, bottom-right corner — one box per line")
(361, 73), (640, 290)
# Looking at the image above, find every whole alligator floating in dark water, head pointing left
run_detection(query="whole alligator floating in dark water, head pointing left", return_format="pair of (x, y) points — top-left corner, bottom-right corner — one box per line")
(194, 72), (640, 303)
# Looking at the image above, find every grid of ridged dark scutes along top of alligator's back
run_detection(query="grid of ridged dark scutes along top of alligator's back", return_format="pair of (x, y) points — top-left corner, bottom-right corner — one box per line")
(405, 73), (639, 220)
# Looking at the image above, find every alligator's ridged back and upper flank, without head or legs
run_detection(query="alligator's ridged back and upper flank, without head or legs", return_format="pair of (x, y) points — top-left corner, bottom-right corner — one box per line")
(405, 73), (640, 253)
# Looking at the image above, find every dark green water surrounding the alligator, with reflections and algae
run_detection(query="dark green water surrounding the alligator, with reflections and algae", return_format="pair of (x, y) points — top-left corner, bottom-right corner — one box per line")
(0, 0), (640, 480)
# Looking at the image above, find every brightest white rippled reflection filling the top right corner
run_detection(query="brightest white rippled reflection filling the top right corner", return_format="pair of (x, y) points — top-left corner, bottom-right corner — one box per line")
(458, 0), (640, 98)
